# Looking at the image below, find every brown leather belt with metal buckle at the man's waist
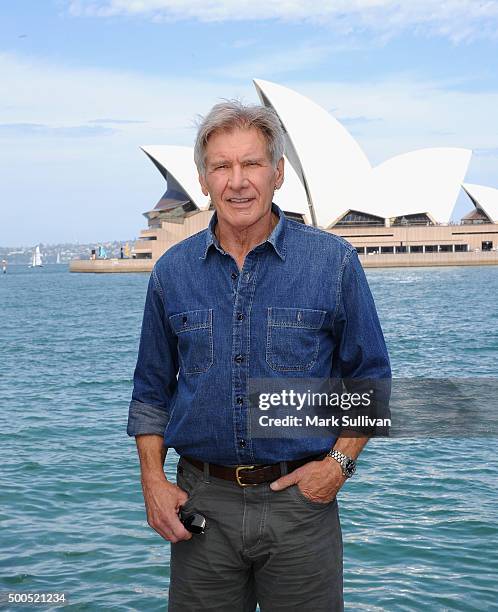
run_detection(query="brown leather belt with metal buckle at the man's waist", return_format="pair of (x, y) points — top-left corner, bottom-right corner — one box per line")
(183, 455), (323, 487)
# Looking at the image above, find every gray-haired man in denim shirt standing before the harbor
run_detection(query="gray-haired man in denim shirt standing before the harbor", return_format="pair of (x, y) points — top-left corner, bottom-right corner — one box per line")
(128, 102), (390, 612)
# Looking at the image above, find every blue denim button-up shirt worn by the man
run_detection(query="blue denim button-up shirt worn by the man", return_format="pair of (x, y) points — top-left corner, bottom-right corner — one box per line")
(127, 204), (391, 465)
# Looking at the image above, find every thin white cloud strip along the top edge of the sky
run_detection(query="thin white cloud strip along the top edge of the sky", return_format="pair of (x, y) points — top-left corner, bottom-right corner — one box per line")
(68, 0), (498, 42)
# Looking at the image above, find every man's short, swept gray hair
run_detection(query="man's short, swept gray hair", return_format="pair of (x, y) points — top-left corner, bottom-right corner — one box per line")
(194, 100), (285, 176)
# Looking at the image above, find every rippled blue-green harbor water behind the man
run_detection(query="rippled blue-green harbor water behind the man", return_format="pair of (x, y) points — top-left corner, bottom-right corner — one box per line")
(0, 265), (498, 611)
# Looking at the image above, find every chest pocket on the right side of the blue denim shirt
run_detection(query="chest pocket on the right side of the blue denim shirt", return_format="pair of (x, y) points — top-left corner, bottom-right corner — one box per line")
(266, 308), (326, 371)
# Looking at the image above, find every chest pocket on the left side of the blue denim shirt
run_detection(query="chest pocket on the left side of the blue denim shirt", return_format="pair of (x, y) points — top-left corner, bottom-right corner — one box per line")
(169, 308), (214, 374)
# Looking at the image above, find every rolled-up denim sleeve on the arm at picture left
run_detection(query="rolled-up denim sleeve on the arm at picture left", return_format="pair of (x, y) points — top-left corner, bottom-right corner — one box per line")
(127, 268), (178, 436)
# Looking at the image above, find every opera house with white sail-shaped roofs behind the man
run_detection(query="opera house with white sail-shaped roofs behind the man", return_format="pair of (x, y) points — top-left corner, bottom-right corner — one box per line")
(72, 80), (498, 267)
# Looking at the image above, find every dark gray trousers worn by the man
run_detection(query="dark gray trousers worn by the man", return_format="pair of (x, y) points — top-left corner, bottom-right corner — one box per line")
(168, 459), (343, 612)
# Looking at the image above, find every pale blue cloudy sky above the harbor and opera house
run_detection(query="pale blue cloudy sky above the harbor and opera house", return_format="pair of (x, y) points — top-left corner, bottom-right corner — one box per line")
(0, 0), (498, 246)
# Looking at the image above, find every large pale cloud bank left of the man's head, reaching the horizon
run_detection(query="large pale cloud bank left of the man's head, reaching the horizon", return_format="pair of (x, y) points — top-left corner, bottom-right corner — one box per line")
(0, 53), (254, 244)
